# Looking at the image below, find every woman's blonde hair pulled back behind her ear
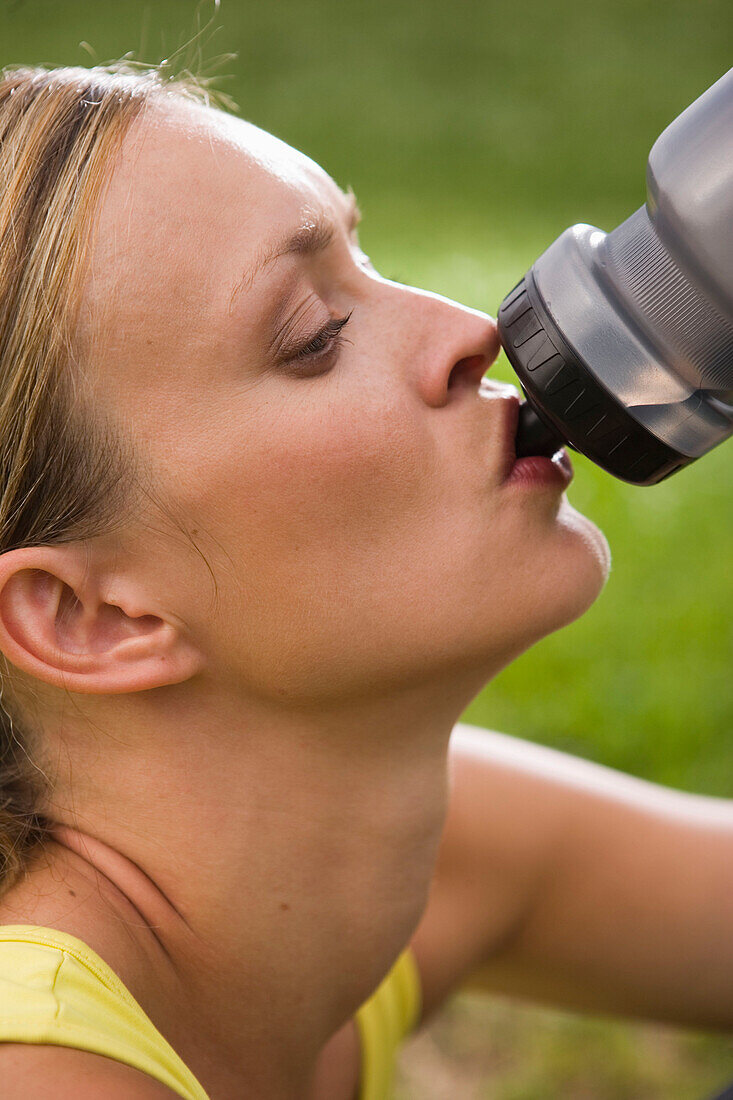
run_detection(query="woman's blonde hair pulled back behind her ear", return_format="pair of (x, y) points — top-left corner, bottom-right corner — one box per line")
(0, 64), (214, 897)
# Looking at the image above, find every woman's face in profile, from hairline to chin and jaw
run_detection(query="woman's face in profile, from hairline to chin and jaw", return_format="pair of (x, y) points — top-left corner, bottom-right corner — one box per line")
(83, 100), (608, 702)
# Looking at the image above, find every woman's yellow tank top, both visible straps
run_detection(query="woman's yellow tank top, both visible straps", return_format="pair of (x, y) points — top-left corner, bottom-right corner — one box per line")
(0, 924), (420, 1100)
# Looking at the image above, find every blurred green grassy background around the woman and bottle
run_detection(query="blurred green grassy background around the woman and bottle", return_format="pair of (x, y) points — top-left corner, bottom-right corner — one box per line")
(0, 0), (733, 1100)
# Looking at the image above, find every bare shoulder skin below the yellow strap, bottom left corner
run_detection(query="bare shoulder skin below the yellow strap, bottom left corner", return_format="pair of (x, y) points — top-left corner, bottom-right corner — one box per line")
(0, 1043), (176, 1100)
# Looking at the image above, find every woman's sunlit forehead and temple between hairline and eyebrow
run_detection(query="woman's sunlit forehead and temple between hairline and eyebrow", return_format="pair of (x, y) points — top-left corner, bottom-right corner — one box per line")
(79, 97), (348, 380)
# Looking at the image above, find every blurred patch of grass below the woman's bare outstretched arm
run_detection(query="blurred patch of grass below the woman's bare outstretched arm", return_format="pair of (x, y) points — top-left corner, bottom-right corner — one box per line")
(395, 993), (733, 1100)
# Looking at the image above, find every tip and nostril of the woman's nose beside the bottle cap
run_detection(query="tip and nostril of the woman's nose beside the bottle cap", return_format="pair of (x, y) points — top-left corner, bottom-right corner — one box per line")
(419, 303), (501, 408)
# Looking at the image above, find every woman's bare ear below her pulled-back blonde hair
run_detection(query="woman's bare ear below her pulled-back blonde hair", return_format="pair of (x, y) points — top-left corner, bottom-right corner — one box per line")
(0, 543), (206, 695)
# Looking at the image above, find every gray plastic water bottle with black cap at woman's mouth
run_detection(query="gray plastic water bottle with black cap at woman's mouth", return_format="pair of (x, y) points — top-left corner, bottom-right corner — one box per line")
(499, 69), (733, 484)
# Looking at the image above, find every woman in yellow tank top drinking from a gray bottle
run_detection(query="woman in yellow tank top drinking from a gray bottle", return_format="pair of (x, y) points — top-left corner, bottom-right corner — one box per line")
(0, 69), (733, 1100)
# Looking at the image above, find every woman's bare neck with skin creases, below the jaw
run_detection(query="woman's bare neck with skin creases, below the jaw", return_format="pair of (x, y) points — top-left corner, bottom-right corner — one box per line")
(22, 683), (470, 1100)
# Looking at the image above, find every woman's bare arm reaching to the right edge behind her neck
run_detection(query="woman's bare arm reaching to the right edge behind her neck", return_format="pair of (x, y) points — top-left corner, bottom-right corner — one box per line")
(413, 726), (733, 1029)
